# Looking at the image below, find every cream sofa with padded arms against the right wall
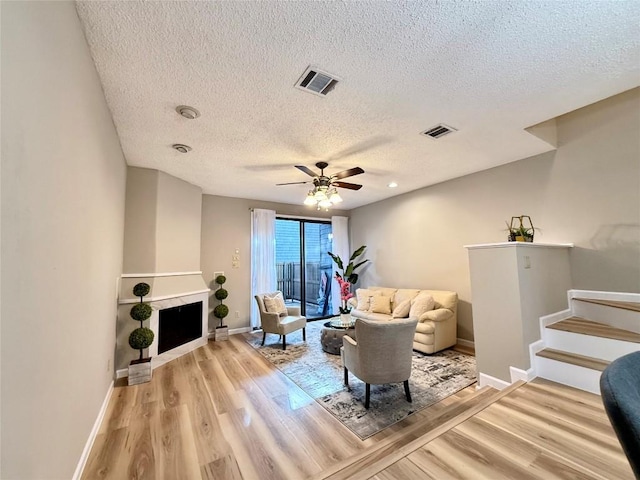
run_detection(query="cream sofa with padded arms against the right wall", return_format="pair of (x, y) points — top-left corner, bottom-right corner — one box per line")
(349, 287), (458, 353)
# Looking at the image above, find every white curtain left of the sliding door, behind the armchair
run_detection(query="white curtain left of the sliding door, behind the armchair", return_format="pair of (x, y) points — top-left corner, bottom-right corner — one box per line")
(251, 208), (277, 328)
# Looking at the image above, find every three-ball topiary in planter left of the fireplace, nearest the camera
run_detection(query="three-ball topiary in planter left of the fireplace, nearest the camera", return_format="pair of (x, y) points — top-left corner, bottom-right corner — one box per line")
(128, 283), (154, 385)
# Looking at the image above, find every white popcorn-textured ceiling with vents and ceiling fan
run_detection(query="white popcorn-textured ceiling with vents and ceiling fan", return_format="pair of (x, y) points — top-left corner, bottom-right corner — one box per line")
(77, 0), (640, 209)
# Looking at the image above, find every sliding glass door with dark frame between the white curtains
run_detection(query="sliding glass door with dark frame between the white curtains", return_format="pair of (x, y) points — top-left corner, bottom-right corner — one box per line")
(276, 218), (333, 320)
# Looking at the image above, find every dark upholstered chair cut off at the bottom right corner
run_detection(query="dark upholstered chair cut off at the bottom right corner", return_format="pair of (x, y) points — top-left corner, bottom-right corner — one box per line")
(600, 352), (640, 479)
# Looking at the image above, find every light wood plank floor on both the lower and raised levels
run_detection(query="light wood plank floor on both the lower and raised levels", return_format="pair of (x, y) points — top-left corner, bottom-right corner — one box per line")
(83, 335), (633, 480)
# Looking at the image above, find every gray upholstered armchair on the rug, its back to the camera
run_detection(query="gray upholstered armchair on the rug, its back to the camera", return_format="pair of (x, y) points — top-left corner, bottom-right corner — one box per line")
(340, 318), (418, 408)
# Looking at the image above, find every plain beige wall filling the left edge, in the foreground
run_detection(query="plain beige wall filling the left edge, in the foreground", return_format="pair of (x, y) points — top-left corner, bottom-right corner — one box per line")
(0, 2), (126, 479)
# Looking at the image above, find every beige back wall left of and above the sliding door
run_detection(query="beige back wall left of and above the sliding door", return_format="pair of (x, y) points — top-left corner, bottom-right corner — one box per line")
(201, 195), (348, 330)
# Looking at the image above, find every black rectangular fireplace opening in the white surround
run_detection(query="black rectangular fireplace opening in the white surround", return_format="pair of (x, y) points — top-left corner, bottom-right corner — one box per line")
(158, 302), (202, 354)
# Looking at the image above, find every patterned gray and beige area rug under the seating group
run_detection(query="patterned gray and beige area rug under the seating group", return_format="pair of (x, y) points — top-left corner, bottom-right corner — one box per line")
(247, 320), (476, 440)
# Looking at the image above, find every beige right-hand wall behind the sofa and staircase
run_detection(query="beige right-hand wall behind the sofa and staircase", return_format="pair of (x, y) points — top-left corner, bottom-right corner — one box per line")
(350, 89), (640, 340)
